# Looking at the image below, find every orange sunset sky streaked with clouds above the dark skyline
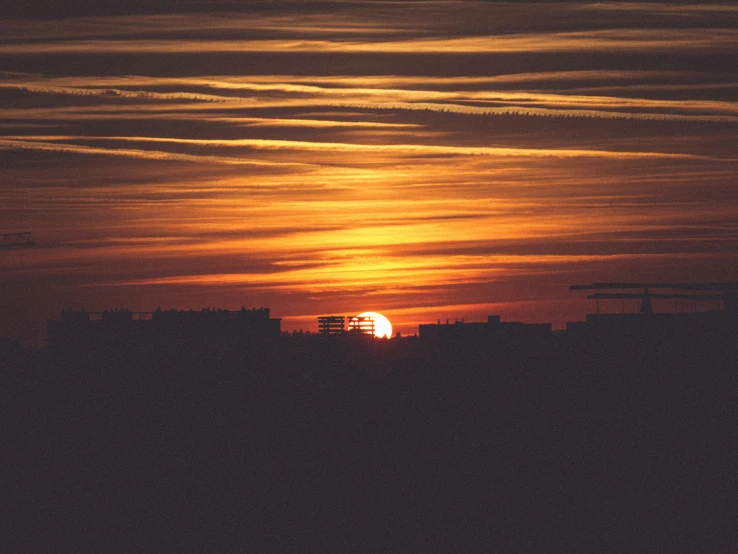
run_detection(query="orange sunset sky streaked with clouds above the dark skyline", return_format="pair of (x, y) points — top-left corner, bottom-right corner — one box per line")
(0, 0), (738, 343)
